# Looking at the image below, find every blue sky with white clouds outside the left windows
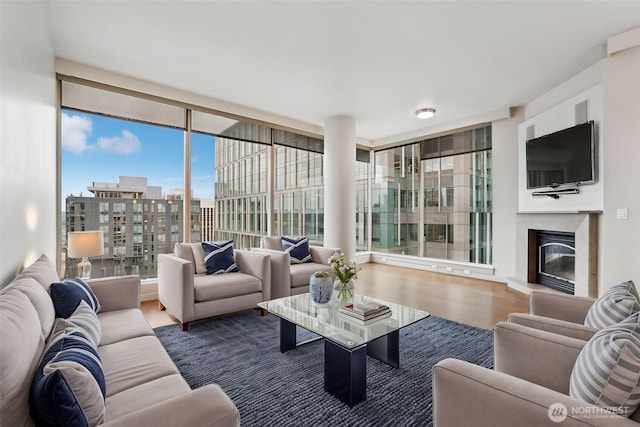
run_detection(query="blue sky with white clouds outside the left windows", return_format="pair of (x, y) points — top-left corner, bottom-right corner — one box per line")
(62, 110), (215, 206)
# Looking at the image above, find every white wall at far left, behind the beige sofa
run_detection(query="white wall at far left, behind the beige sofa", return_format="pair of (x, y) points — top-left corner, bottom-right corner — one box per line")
(0, 1), (58, 286)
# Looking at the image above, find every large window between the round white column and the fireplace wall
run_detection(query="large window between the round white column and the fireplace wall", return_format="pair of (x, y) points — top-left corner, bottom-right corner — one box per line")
(371, 126), (492, 264)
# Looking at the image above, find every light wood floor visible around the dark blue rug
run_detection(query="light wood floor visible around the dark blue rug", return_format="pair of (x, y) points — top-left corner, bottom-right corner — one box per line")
(142, 263), (529, 329)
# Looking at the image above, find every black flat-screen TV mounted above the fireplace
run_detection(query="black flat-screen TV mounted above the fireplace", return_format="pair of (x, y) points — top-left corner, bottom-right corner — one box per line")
(526, 121), (595, 188)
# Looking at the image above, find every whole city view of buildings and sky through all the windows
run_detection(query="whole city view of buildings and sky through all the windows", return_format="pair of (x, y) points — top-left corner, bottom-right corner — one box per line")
(61, 106), (492, 278)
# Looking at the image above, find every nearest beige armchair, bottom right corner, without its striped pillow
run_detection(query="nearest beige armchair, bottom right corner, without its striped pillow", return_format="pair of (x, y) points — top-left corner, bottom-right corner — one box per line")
(433, 322), (640, 427)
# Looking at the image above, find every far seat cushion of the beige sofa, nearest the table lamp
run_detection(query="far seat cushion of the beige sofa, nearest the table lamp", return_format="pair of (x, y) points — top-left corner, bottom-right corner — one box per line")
(98, 308), (154, 345)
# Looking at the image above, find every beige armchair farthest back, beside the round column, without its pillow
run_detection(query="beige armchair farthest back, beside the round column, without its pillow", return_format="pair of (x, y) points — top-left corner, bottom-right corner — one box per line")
(251, 236), (340, 299)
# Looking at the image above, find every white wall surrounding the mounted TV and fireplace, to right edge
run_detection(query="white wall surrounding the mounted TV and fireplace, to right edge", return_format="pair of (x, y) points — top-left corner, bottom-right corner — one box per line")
(492, 27), (640, 294)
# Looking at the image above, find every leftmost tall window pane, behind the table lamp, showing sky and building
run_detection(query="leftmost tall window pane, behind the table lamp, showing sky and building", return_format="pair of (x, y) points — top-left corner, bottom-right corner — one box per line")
(61, 109), (184, 278)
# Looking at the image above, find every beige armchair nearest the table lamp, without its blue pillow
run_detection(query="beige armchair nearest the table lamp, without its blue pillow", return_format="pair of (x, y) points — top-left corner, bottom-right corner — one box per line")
(158, 243), (271, 331)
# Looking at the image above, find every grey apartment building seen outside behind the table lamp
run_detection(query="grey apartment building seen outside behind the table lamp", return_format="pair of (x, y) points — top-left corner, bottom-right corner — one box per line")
(66, 176), (200, 278)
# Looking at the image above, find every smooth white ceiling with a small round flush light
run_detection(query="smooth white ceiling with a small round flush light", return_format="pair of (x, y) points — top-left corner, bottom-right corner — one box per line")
(50, 0), (640, 145)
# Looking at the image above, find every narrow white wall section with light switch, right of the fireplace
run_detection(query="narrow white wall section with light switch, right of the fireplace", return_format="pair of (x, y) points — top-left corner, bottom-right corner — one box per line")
(600, 42), (640, 293)
